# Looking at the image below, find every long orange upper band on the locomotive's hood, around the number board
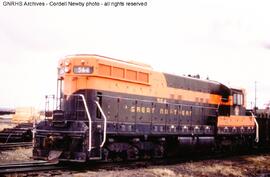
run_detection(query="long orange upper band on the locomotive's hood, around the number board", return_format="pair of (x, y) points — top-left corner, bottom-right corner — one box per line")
(59, 55), (232, 105)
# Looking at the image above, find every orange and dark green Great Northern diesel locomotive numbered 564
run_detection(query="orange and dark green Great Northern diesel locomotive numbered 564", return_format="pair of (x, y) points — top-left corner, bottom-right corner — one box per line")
(33, 55), (260, 162)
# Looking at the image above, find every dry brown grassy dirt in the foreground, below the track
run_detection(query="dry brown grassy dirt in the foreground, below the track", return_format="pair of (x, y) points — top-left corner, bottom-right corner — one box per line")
(66, 154), (270, 177)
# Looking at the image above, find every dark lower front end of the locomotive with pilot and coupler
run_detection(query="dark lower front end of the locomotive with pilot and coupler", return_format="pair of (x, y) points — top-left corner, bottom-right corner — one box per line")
(33, 122), (88, 162)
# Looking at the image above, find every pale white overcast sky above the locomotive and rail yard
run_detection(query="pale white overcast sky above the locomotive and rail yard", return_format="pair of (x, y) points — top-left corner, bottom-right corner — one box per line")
(0, 0), (270, 108)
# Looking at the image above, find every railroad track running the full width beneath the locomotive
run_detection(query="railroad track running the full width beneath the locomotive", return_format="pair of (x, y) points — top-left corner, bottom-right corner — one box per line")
(0, 149), (269, 176)
